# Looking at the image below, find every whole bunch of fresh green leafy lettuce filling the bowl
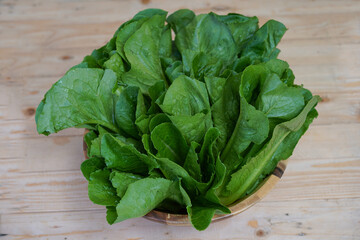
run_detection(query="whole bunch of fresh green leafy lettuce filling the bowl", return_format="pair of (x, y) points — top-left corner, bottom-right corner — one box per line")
(36, 9), (319, 230)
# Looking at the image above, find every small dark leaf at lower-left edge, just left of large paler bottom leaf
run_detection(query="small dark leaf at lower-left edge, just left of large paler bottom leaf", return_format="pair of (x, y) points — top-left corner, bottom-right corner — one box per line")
(88, 169), (119, 206)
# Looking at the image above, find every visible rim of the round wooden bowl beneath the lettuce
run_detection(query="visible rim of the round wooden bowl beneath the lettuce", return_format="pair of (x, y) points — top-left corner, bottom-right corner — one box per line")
(83, 130), (288, 226)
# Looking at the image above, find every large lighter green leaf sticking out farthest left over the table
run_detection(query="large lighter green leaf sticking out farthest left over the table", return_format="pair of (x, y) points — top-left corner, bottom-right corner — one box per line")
(35, 68), (118, 135)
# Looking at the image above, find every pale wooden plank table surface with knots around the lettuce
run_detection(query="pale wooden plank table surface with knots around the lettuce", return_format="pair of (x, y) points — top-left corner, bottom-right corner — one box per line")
(0, 0), (360, 240)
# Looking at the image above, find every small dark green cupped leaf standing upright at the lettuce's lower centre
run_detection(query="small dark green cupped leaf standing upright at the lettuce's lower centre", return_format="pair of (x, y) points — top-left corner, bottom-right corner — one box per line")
(151, 123), (188, 165)
